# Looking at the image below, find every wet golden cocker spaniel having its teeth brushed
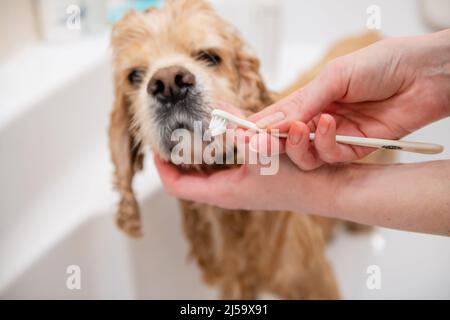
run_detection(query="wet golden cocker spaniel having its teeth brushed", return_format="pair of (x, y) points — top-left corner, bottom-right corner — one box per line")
(109, 0), (378, 299)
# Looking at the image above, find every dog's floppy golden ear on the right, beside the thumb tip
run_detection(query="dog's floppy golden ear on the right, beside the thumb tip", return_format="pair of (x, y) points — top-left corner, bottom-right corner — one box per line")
(235, 35), (272, 112)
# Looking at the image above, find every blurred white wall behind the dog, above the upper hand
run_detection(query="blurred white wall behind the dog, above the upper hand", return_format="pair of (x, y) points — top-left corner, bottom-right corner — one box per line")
(211, 0), (440, 84)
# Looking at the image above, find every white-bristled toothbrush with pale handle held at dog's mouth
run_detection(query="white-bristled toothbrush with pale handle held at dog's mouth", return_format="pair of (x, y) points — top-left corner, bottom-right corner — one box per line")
(209, 109), (444, 154)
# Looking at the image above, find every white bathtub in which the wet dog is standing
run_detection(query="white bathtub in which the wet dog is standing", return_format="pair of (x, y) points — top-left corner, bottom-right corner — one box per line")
(0, 1), (450, 299)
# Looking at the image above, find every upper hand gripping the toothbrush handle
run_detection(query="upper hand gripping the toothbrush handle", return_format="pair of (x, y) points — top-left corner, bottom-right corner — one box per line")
(250, 30), (450, 170)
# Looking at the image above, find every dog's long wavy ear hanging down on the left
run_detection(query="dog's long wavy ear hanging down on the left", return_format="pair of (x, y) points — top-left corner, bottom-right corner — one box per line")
(109, 83), (143, 237)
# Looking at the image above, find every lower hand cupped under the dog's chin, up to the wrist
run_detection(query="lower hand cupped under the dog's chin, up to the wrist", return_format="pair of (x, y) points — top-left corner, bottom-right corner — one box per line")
(155, 156), (342, 215)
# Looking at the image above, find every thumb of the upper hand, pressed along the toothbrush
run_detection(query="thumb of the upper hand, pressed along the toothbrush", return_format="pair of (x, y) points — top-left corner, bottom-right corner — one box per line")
(249, 58), (351, 132)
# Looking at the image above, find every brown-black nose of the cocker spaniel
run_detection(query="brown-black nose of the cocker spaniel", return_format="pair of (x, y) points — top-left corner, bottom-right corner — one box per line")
(147, 66), (195, 103)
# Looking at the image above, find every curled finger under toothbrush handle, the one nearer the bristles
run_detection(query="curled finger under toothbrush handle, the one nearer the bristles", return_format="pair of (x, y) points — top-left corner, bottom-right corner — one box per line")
(286, 121), (323, 171)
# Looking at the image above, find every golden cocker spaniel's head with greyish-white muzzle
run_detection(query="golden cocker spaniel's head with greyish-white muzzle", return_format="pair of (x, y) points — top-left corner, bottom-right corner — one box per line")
(110, 0), (269, 233)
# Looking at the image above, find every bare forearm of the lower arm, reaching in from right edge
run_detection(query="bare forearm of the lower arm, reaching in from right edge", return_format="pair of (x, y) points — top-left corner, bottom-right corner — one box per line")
(328, 160), (450, 235)
